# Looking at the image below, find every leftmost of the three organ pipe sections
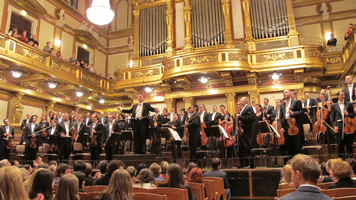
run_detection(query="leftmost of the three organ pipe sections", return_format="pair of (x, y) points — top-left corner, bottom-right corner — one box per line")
(139, 5), (167, 57)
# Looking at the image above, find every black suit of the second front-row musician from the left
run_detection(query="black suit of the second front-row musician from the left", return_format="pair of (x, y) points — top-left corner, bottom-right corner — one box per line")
(25, 124), (42, 161)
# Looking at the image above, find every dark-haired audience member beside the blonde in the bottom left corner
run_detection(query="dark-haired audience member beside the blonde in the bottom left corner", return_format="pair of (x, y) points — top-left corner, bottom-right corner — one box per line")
(28, 169), (54, 200)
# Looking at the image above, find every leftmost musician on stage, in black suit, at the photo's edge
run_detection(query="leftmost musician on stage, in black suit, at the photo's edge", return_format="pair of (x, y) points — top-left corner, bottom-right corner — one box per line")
(0, 118), (15, 160)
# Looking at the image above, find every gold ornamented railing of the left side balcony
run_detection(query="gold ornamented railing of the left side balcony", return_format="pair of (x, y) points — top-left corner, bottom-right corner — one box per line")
(0, 33), (110, 92)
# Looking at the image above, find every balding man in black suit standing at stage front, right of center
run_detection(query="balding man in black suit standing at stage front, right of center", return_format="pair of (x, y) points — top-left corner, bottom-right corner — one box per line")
(234, 97), (254, 168)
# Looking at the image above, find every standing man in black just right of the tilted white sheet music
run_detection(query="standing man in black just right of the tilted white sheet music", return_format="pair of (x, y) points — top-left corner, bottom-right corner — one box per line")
(185, 105), (201, 162)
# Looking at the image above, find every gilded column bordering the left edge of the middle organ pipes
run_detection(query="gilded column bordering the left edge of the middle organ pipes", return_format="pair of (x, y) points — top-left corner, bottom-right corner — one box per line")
(184, 0), (193, 52)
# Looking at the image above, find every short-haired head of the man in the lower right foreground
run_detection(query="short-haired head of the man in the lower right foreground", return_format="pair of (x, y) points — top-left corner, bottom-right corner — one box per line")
(290, 154), (321, 188)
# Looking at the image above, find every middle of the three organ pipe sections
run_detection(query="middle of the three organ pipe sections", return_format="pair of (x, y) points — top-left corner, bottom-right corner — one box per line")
(191, 0), (225, 47)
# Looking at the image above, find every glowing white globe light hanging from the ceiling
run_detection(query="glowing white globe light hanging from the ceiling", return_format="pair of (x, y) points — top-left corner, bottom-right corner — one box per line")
(86, 0), (115, 25)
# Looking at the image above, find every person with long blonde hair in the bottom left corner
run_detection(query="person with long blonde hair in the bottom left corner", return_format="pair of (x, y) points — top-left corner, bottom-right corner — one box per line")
(0, 166), (28, 200)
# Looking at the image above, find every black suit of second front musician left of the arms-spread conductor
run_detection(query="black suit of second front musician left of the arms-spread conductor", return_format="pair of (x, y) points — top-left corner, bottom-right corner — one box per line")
(89, 121), (105, 161)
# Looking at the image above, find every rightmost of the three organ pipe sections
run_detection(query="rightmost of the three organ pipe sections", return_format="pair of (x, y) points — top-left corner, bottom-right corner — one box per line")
(250, 0), (289, 39)
